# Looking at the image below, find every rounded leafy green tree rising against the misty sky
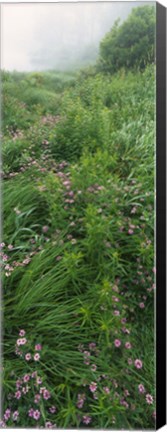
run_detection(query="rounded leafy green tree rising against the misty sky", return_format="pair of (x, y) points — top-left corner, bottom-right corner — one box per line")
(97, 5), (155, 73)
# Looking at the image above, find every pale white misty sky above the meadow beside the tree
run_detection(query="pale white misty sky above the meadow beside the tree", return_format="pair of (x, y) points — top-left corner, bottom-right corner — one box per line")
(1, 1), (155, 71)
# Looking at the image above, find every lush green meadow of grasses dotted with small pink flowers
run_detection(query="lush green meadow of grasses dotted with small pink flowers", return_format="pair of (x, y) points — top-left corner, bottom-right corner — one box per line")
(0, 8), (156, 429)
